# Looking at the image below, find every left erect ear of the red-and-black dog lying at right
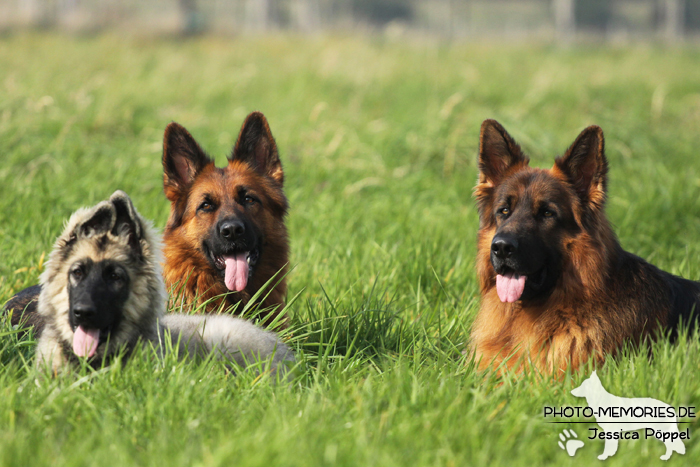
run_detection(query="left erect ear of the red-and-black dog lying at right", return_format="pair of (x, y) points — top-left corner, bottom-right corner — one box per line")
(479, 120), (530, 186)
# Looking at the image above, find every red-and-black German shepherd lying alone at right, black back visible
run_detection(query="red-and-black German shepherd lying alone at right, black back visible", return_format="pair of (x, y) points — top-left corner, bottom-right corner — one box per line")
(470, 120), (700, 374)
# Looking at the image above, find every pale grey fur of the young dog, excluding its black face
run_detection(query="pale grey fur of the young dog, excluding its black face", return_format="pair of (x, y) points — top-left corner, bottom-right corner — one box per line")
(36, 191), (294, 372)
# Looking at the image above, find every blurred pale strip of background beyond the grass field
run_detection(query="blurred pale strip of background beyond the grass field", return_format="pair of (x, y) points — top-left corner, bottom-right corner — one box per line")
(0, 0), (700, 41)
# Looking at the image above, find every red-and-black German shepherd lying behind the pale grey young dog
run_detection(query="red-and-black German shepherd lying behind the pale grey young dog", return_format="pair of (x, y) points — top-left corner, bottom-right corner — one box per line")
(5, 112), (289, 336)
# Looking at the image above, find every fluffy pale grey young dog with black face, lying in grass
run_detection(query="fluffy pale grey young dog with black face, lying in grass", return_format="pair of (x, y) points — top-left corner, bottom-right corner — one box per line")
(36, 191), (294, 375)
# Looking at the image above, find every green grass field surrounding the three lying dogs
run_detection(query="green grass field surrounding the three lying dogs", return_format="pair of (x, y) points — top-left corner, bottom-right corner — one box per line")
(0, 34), (700, 466)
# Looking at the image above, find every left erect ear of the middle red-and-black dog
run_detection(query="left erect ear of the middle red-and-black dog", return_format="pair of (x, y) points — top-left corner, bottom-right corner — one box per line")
(163, 122), (214, 201)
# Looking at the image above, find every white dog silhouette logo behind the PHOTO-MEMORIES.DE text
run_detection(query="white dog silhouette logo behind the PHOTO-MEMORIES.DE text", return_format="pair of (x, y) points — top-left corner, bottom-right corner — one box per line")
(571, 371), (685, 460)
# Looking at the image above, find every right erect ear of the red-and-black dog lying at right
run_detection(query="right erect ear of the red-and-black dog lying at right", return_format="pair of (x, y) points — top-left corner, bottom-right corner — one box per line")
(554, 125), (608, 207)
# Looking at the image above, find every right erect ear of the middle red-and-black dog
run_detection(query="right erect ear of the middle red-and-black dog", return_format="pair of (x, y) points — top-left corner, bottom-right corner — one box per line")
(228, 112), (284, 185)
